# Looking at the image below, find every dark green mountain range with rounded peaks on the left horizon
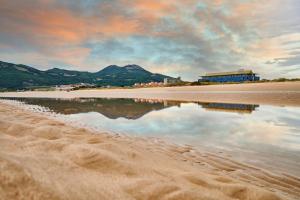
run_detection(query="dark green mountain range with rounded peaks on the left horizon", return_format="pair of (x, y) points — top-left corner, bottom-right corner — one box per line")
(0, 61), (172, 89)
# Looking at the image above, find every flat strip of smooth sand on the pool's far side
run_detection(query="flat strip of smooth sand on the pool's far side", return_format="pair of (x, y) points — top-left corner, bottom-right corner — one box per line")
(0, 81), (300, 106)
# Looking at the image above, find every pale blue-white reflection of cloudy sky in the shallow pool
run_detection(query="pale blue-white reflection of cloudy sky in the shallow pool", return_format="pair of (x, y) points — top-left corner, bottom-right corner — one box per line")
(63, 103), (300, 152)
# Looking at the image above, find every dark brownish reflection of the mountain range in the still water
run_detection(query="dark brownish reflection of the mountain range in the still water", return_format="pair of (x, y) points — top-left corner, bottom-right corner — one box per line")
(8, 98), (180, 119)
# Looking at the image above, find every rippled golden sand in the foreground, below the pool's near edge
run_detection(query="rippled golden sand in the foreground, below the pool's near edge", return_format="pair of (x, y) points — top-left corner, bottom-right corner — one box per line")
(0, 103), (300, 200)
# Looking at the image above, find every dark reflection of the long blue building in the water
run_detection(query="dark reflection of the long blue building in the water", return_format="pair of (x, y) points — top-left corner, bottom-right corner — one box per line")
(199, 103), (259, 113)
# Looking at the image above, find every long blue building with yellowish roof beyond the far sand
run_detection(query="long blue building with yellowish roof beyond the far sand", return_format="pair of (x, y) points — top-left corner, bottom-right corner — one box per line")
(198, 69), (259, 83)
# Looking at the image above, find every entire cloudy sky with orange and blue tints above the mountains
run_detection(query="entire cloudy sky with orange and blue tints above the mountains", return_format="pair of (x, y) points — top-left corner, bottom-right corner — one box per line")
(0, 0), (300, 81)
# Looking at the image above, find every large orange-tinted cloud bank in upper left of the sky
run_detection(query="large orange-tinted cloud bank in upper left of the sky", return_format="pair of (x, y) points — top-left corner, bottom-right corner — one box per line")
(0, 0), (146, 46)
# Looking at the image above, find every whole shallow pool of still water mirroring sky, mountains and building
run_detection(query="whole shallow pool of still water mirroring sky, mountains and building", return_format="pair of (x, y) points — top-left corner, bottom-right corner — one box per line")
(2, 98), (300, 176)
